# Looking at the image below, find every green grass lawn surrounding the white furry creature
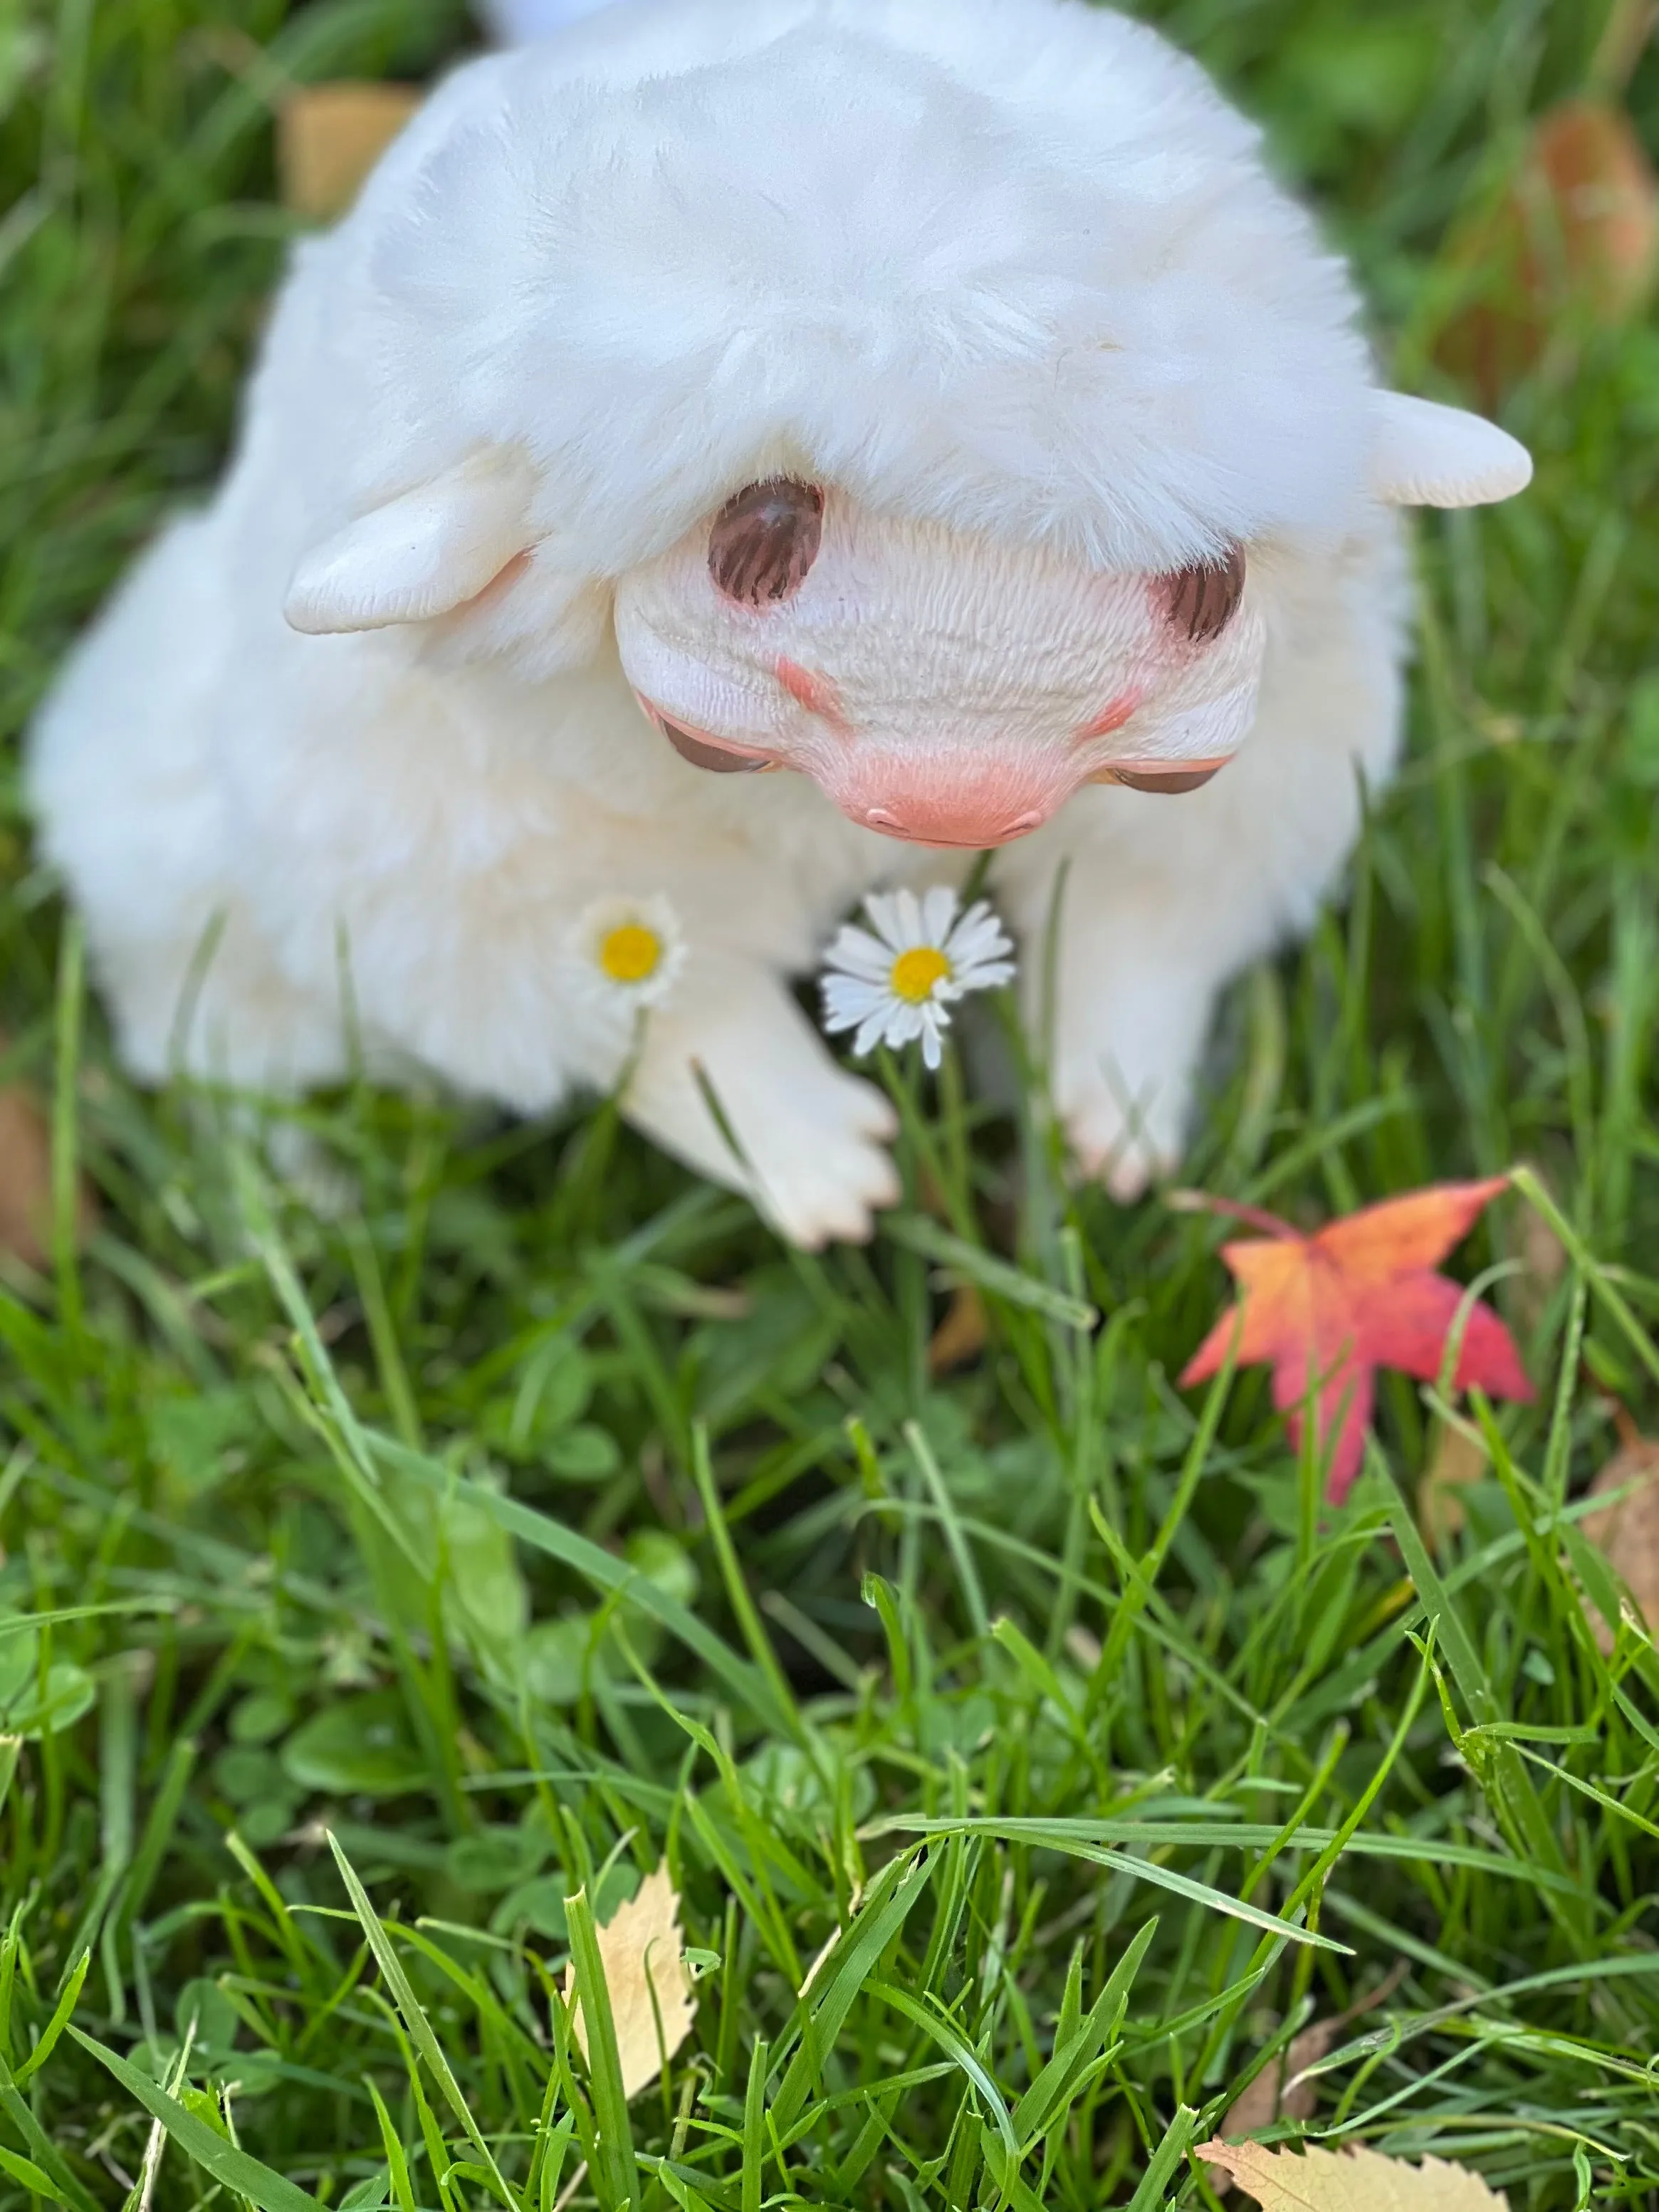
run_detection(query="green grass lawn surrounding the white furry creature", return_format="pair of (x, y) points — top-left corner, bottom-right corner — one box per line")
(0, 0), (1659, 2212)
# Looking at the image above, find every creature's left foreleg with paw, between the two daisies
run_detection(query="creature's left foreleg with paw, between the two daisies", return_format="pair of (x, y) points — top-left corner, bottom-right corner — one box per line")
(622, 951), (898, 1247)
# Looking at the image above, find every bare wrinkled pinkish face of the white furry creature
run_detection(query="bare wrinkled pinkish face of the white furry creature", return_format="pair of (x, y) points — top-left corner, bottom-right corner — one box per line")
(617, 478), (1263, 847)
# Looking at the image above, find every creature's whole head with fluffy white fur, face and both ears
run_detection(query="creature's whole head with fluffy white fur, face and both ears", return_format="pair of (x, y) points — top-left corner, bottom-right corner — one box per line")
(288, 0), (1529, 847)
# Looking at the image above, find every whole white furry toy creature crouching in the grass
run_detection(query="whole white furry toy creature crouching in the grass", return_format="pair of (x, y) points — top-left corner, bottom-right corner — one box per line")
(31, 0), (1529, 1243)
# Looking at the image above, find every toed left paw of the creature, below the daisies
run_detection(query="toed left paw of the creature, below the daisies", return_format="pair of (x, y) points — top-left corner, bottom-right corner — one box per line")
(745, 1075), (900, 1252)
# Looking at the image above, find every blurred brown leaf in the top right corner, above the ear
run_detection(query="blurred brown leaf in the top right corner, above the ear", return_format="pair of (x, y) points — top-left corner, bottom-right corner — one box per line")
(1438, 98), (1659, 405)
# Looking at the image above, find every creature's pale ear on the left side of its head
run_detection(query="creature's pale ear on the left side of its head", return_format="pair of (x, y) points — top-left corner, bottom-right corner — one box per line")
(283, 454), (533, 635)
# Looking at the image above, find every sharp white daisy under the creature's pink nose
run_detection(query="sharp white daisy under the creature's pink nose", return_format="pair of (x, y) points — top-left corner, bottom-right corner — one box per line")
(823, 885), (1013, 1069)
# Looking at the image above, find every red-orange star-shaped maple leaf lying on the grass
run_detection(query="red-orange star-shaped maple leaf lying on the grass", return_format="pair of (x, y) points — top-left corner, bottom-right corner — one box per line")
(1181, 1175), (1533, 1504)
